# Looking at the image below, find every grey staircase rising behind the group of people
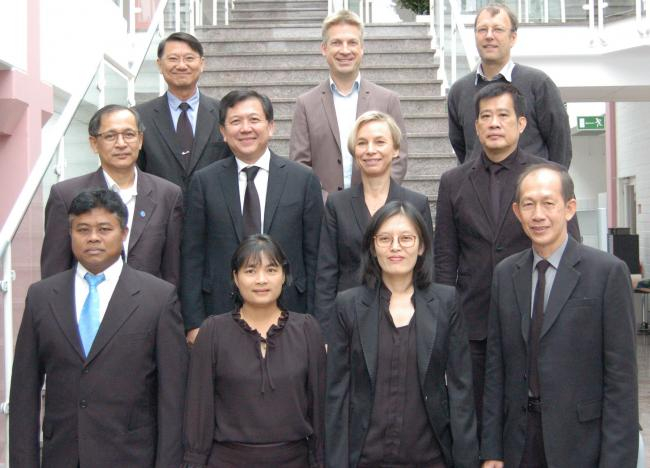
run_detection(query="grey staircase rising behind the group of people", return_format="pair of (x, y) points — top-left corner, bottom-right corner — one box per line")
(197, 0), (456, 215)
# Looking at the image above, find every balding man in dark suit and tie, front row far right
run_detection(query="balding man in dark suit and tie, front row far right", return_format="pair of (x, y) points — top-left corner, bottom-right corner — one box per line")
(481, 164), (639, 468)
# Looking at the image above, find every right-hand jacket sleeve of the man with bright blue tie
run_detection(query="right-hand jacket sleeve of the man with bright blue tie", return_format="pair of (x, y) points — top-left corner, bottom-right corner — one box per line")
(156, 290), (187, 468)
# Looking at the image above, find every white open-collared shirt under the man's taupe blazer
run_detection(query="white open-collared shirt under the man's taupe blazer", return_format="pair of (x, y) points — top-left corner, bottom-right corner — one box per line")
(330, 74), (361, 188)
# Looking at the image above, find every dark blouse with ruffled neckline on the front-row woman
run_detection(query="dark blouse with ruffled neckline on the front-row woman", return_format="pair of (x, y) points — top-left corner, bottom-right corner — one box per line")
(184, 311), (325, 466)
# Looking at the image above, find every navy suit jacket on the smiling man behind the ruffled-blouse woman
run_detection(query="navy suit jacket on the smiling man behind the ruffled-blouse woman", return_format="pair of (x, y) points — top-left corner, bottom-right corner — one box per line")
(181, 152), (323, 330)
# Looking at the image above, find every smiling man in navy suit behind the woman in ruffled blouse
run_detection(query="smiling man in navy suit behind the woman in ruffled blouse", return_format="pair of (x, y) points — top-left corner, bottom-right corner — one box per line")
(181, 90), (323, 342)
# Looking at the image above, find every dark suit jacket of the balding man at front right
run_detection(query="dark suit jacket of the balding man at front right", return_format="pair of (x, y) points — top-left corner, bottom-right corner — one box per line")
(481, 238), (639, 468)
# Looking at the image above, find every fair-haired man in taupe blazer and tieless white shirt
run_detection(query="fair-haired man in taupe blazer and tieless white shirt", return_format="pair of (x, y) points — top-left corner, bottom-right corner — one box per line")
(289, 10), (408, 196)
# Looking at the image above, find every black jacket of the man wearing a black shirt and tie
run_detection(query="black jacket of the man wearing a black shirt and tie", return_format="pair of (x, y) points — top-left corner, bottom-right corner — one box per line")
(434, 150), (580, 340)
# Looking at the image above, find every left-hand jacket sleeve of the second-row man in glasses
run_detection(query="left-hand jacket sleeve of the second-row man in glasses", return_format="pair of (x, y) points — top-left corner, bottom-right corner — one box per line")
(41, 185), (74, 278)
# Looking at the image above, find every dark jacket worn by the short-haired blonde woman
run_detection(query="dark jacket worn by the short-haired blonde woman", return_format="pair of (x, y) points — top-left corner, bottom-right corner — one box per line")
(315, 179), (433, 336)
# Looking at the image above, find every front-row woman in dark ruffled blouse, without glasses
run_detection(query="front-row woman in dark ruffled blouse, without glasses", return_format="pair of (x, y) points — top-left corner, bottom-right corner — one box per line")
(184, 235), (325, 468)
